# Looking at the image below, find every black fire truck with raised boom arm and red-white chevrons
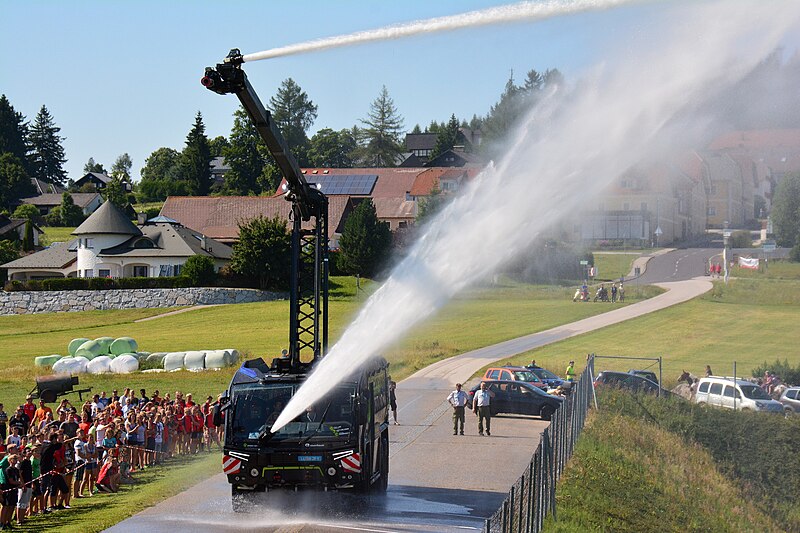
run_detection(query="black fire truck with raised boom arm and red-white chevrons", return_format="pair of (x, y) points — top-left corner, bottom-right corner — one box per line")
(201, 49), (389, 511)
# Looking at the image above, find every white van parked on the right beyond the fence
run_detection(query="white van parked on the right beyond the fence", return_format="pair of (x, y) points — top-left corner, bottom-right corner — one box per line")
(694, 376), (783, 413)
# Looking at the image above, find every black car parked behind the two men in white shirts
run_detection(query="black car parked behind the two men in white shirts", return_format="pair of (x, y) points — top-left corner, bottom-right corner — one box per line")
(467, 380), (564, 420)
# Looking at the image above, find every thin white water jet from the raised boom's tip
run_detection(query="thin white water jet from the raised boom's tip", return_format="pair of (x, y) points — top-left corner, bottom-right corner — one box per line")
(242, 0), (641, 62)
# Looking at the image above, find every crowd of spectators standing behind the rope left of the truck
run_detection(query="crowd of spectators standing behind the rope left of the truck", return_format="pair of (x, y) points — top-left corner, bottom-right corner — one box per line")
(0, 389), (222, 530)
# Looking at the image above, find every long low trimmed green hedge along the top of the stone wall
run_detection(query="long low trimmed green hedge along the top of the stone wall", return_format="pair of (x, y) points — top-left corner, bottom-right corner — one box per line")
(4, 276), (193, 292)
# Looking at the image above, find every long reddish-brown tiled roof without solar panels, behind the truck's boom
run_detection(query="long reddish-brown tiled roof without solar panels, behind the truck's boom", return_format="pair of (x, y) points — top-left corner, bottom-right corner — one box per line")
(160, 196), (350, 242)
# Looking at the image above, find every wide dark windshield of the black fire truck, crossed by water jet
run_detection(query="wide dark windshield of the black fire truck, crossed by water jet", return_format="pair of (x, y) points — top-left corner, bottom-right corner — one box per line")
(229, 383), (355, 444)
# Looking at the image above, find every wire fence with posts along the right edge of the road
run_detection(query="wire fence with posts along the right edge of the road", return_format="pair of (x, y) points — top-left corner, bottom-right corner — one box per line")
(484, 357), (594, 533)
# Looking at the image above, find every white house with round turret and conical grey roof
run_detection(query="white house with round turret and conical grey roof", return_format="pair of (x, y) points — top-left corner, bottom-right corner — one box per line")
(1, 202), (232, 280)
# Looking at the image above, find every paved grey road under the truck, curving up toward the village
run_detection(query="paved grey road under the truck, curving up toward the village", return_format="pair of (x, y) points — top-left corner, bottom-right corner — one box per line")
(108, 250), (711, 533)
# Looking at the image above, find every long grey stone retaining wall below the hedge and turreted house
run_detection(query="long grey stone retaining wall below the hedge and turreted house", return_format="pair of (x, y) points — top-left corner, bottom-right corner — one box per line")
(0, 287), (287, 315)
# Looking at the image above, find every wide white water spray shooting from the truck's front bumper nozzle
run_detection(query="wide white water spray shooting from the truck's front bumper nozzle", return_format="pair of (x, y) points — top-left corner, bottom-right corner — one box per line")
(270, 1), (800, 431)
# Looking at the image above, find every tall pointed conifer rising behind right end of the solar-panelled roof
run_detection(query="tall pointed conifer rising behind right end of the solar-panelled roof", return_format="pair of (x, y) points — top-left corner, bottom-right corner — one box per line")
(359, 85), (403, 167)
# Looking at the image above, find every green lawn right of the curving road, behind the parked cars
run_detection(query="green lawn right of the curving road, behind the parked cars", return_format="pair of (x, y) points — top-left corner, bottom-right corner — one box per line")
(494, 279), (800, 387)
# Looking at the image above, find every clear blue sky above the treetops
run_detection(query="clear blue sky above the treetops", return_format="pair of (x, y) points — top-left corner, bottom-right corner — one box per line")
(0, 0), (796, 180)
